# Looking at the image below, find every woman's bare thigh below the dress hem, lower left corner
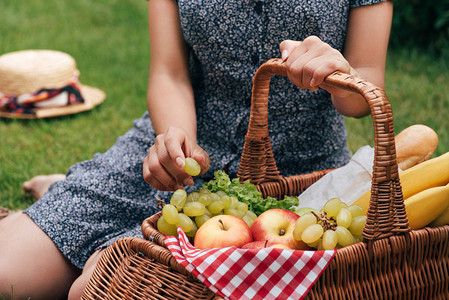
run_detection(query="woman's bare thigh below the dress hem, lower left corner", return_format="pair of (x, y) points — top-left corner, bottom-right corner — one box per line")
(0, 213), (81, 299)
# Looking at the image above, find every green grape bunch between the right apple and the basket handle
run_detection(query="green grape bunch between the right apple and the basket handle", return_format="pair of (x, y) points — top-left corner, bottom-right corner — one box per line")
(293, 198), (366, 250)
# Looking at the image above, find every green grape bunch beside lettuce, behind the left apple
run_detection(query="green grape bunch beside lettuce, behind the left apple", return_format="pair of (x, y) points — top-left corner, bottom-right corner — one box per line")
(157, 188), (257, 238)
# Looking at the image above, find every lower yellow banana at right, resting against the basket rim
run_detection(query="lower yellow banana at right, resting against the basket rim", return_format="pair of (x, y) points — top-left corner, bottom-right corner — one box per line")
(404, 184), (449, 230)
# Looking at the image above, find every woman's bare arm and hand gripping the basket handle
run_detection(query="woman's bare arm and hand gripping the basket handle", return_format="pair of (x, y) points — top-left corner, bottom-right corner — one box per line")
(280, 1), (393, 117)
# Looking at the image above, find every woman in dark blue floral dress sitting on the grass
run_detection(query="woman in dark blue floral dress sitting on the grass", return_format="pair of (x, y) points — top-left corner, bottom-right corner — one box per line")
(0, 0), (392, 299)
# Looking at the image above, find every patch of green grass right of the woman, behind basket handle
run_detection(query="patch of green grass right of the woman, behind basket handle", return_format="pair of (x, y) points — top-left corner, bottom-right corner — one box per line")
(346, 49), (449, 156)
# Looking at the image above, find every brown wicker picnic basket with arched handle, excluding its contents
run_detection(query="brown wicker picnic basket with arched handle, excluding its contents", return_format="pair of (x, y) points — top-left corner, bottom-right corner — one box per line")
(83, 59), (449, 299)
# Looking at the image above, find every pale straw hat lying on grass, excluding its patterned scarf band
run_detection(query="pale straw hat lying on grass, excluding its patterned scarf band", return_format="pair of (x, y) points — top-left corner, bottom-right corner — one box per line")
(0, 50), (106, 119)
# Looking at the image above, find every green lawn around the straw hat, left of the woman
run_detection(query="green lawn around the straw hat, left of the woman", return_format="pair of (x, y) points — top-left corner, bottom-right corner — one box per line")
(0, 0), (149, 209)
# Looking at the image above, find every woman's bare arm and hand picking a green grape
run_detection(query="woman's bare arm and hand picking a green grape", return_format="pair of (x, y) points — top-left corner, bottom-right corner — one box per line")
(143, 0), (209, 190)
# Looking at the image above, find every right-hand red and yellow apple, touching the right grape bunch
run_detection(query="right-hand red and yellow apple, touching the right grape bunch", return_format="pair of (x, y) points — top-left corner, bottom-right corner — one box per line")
(251, 208), (309, 250)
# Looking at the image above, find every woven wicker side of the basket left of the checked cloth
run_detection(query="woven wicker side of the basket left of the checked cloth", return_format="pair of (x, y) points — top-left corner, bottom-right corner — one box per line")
(82, 238), (219, 299)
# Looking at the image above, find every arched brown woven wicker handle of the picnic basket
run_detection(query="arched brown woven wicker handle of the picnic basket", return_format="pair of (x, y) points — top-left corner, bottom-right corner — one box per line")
(237, 58), (410, 241)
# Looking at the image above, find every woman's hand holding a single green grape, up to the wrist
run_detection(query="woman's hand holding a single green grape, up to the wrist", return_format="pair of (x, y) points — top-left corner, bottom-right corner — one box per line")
(143, 127), (210, 191)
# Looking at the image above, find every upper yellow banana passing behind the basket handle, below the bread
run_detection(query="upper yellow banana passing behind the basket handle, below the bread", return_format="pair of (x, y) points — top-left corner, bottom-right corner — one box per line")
(353, 152), (449, 214)
